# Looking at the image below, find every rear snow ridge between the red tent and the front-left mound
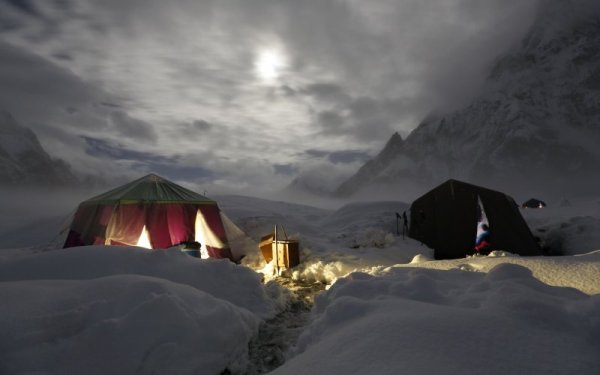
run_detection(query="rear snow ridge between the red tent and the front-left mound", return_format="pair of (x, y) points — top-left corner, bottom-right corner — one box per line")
(0, 246), (276, 318)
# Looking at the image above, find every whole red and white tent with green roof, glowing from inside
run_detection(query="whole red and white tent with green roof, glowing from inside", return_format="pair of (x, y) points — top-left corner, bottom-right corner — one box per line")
(64, 174), (233, 260)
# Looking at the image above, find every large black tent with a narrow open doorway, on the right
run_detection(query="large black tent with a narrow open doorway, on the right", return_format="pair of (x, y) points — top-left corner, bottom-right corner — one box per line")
(409, 180), (541, 259)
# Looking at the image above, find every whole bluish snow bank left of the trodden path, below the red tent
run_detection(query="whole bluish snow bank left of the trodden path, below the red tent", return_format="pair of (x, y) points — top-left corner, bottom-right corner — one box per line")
(0, 246), (289, 374)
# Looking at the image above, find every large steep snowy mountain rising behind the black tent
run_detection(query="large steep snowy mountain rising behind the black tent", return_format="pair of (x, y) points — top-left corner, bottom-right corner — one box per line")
(337, 0), (600, 200)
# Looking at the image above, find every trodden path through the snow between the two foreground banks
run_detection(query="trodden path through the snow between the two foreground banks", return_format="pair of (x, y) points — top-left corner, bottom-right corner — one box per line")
(247, 277), (325, 375)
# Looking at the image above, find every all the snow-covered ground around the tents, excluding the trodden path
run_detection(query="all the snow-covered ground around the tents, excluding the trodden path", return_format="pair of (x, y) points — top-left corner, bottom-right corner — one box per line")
(0, 196), (600, 375)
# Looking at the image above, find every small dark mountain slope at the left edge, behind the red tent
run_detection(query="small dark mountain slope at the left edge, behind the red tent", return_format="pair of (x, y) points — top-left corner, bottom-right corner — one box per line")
(0, 111), (76, 186)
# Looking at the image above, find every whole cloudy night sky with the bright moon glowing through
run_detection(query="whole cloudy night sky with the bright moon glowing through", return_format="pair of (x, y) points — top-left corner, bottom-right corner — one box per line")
(0, 0), (538, 193)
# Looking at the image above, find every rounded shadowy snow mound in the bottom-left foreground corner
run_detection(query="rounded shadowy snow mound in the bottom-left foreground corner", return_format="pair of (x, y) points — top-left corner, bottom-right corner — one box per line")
(0, 275), (259, 374)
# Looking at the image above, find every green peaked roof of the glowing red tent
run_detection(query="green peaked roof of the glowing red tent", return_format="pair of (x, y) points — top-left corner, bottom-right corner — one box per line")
(81, 174), (216, 205)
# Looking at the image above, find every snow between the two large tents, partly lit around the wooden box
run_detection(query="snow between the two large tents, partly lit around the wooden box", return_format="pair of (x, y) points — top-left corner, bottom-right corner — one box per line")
(219, 196), (433, 284)
